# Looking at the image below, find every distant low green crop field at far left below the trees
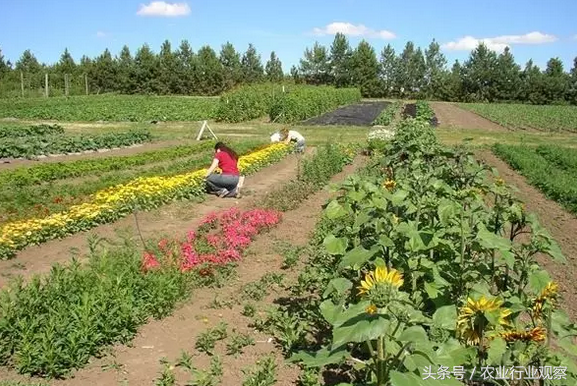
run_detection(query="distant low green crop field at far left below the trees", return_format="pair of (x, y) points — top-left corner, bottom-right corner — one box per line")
(0, 95), (218, 122)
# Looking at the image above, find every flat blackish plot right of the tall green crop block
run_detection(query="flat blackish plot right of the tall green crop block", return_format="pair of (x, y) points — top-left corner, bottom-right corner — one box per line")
(303, 102), (390, 126)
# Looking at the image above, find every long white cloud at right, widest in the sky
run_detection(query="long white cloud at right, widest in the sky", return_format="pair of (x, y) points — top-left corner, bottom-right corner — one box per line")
(441, 31), (557, 52)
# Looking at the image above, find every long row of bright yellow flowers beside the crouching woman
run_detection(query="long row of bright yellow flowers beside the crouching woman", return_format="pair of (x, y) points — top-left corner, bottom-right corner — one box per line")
(0, 143), (291, 259)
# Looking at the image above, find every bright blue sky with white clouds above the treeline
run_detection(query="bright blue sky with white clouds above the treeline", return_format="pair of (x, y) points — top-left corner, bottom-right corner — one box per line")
(0, 0), (577, 71)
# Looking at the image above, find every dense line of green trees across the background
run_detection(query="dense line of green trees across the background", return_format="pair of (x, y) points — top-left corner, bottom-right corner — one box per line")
(0, 34), (577, 104)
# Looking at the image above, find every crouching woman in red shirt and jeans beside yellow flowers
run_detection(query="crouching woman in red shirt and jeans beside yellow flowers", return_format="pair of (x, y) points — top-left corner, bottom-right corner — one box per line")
(206, 142), (242, 198)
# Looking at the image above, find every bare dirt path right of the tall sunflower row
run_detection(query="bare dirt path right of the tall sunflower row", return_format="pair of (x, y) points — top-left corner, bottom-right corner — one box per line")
(476, 150), (577, 320)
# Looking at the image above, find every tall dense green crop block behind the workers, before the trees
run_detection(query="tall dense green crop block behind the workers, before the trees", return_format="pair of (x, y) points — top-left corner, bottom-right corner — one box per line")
(216, 84), (361, 123)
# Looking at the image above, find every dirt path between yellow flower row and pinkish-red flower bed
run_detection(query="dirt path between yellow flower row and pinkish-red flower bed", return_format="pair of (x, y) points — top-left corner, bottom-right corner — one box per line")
(0, 149), (312, 287)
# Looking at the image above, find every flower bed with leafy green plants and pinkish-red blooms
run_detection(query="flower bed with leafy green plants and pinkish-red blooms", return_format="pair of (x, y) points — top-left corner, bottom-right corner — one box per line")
(0, 208), (281, 378)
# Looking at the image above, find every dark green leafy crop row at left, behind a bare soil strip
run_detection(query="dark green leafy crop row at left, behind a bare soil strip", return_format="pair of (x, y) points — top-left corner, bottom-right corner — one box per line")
(0, 130), (152, 158)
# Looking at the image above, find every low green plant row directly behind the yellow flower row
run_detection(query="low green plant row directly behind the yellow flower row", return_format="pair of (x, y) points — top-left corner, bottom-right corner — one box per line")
(0, 140), (262, 223)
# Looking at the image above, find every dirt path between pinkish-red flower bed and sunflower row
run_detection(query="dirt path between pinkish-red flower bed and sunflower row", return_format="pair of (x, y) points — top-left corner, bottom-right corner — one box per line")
(0, 159), (363, 386)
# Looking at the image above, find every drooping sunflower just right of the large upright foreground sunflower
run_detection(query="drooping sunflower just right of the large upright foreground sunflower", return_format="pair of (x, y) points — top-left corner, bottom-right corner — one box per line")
(457, 296), (511, 345)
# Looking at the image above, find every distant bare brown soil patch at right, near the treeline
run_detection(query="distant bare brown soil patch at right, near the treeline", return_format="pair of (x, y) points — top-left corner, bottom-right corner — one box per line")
(430, 102), (507, 131)
